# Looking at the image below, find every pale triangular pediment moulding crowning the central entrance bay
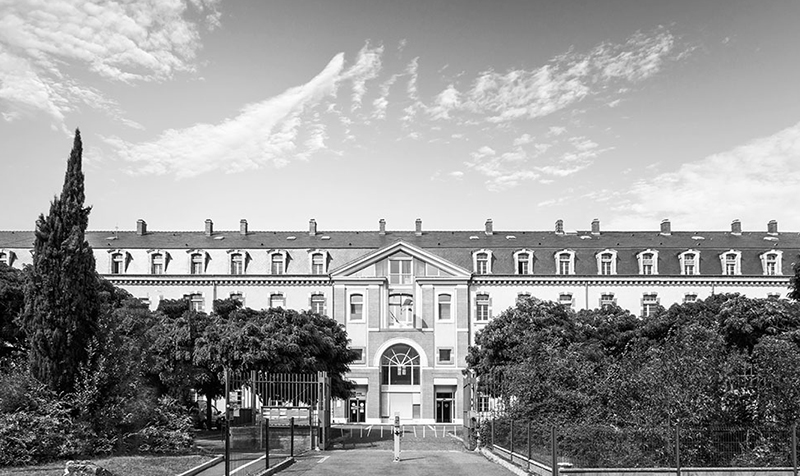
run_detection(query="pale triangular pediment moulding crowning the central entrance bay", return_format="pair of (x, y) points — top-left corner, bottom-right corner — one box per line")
(331, 241), (471, 279)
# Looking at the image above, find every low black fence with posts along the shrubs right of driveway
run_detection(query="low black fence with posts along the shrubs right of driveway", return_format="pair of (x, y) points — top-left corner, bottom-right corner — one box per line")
(482, 416), (798, 474)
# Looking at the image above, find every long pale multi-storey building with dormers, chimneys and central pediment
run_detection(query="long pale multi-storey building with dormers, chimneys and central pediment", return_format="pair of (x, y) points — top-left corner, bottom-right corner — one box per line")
(0, 220), (800, 423)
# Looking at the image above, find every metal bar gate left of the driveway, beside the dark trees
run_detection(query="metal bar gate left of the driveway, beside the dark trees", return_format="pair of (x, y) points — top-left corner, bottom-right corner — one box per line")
(225, 370), (331, 476)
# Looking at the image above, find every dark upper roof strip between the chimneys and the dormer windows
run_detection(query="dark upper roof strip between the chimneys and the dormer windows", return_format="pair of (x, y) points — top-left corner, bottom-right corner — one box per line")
(0, 230), (800, 251)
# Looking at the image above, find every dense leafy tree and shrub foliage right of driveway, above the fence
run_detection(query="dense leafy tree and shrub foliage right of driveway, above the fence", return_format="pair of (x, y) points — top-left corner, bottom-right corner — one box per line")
(467, 294), (800, 427)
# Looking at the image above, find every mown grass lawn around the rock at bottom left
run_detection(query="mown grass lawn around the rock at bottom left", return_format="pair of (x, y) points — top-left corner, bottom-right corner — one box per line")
(0, 455), (212, 476)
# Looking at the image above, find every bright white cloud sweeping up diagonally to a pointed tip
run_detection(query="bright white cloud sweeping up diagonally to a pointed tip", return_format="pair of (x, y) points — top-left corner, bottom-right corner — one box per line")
(106, 53), (352, 177)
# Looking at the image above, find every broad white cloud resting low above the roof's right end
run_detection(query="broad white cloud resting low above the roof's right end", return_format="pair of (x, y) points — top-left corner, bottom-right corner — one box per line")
(613, 123), (800, 230)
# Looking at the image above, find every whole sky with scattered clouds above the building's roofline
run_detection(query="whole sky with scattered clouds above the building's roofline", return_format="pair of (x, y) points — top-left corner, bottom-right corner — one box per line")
(0, 0), (800, 231)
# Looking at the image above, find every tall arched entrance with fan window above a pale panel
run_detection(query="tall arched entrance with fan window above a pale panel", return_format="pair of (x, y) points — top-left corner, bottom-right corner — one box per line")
(381, 344), (421, 420)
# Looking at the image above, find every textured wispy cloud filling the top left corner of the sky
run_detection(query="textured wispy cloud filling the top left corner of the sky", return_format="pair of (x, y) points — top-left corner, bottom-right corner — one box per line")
(0, 0), (219, 128)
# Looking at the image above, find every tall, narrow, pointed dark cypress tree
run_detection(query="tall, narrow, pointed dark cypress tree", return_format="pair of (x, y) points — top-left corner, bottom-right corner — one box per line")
(23, 129), (99, 392)
